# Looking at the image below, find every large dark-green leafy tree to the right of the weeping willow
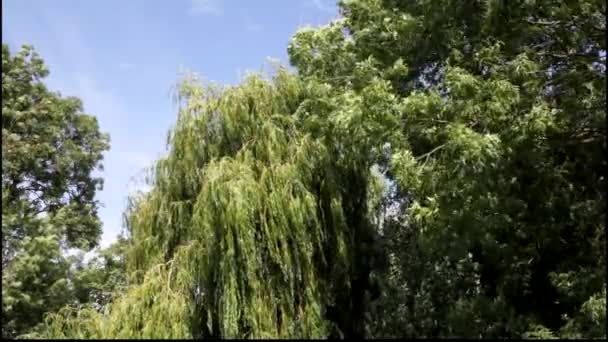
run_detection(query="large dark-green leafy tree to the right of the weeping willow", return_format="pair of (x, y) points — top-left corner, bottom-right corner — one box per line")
(289, 0), (606, 337)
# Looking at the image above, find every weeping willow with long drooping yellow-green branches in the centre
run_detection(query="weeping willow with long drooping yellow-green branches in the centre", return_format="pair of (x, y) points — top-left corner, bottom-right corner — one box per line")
(34, 69), (391, 338)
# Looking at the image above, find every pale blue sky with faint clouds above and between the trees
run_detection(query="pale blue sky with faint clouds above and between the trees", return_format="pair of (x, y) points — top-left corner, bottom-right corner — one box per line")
(2, 0), (337, 246)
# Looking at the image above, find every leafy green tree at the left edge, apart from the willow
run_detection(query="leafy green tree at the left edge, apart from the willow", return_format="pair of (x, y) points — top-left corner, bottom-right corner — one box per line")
(2, 44), (109, 338)
